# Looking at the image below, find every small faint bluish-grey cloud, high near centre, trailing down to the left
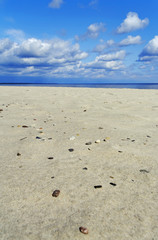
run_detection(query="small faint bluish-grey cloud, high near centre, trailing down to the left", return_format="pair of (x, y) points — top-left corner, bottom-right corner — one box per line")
(75, 23), (105, 41)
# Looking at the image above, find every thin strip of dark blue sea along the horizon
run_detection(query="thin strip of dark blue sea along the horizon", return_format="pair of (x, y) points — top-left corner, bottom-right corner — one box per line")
(0, 83), (158, 89)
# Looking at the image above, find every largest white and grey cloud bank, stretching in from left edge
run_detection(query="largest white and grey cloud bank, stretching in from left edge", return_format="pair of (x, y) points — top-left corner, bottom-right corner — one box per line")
(0, 38), (88, 68)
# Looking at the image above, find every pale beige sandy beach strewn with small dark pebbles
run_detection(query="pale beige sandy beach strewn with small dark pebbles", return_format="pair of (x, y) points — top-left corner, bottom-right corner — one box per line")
(0, 86), (158, 240)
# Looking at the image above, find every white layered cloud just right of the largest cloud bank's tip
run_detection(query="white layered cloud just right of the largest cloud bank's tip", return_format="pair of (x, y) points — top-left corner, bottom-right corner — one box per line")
(83, 50), (126, 71)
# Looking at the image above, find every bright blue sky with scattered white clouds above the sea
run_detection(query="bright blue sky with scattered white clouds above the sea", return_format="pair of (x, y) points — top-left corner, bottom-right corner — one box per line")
(0, 0), (158, 83)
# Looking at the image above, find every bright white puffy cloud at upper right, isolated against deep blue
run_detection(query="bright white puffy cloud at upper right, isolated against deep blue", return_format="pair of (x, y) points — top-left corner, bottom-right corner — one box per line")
(116, 12), (149, 34)
